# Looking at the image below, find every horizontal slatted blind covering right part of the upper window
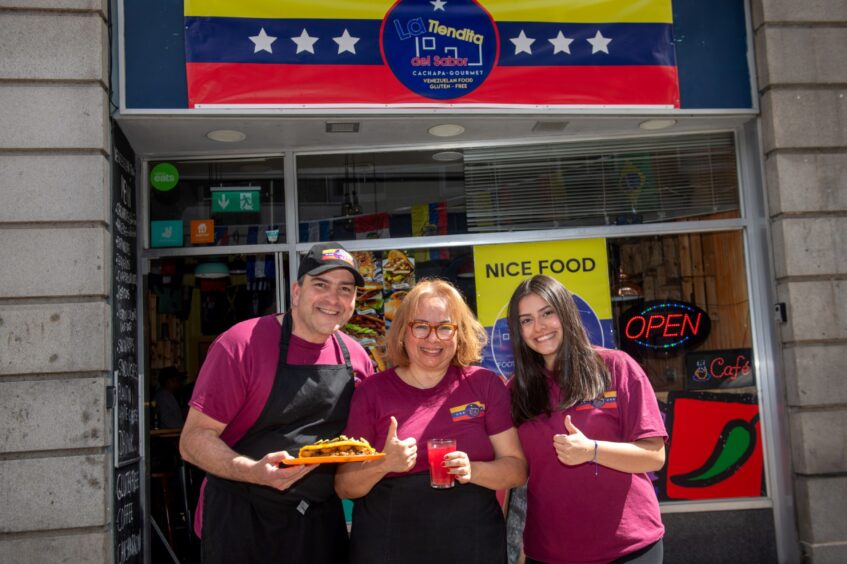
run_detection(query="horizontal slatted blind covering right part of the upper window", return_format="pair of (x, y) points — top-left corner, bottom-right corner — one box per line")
(464, 133), (739, 232)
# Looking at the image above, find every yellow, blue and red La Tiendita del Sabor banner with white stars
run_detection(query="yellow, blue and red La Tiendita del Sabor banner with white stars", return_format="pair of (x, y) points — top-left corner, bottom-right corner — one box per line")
(184, 0), (679, 108)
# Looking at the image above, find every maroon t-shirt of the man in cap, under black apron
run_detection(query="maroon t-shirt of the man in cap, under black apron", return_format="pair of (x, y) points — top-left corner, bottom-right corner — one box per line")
(188, 314), (373, 536)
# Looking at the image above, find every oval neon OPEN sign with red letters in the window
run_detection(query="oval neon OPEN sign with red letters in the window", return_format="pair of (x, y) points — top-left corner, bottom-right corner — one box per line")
(621, 300), (712, 351)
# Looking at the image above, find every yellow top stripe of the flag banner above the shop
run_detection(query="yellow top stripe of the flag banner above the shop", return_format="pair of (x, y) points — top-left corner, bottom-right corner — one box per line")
(189, 0), (673, 23)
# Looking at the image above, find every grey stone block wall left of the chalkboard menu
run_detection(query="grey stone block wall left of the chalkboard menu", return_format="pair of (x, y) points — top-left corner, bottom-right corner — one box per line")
(0, 0), (112, 563)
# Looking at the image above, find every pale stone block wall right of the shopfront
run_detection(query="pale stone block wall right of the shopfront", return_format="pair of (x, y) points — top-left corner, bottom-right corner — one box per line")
(752, 0), (847, 564)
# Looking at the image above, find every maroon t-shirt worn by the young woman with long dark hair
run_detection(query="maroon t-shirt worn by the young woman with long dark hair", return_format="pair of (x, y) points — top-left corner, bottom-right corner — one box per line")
(518, 349), (667, 564)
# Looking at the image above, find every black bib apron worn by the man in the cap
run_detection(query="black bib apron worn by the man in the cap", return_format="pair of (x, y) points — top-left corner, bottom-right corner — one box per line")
(202, 315), (353, 564)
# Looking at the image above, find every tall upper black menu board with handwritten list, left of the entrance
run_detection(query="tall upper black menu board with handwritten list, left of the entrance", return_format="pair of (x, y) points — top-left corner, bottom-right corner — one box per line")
(112, 126), (141, 468)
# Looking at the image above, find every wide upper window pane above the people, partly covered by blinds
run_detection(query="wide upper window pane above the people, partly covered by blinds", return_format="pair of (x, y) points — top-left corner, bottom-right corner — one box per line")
(297, 133), (739, 242)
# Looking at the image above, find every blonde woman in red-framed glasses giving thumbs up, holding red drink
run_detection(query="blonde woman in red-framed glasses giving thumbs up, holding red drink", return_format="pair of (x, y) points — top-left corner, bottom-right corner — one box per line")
(335, 280), (526, 564)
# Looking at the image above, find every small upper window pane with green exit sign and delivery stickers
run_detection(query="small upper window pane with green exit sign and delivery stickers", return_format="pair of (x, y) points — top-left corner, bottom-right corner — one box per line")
(147, 157), (285, 248)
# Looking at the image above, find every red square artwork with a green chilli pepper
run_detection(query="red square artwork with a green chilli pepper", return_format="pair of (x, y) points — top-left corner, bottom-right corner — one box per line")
(660, 392), (764, 499)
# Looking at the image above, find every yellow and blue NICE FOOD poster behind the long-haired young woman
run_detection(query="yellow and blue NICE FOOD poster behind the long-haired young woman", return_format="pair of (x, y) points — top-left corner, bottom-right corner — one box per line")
(474, 239), (615, 380)
